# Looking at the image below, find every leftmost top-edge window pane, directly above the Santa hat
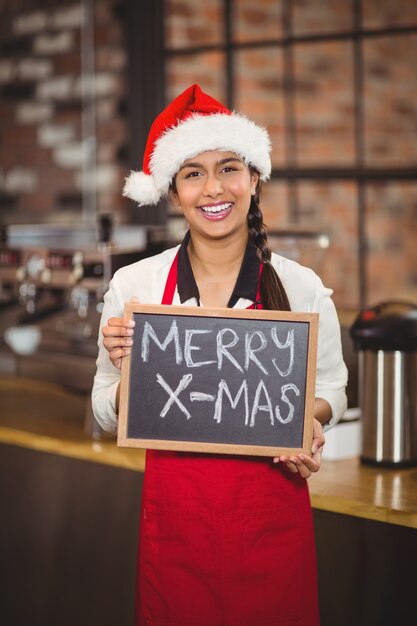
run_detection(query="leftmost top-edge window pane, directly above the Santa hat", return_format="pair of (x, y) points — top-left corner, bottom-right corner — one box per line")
(165, 0), (224, 48)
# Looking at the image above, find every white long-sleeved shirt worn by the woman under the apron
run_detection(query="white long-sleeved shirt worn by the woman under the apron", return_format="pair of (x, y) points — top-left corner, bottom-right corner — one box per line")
(92, 246), (347, 432)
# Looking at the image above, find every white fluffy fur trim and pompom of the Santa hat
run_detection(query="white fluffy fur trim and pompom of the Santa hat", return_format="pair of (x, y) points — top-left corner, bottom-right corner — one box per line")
(123, 113), (271, 206)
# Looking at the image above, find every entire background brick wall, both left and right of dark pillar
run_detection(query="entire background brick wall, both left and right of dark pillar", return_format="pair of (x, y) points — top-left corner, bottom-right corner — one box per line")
(0, 0), (417, 307)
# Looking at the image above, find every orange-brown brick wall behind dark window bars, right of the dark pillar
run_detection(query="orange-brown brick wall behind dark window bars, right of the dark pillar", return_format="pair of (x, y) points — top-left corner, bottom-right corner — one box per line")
(166, 0), (417, 307)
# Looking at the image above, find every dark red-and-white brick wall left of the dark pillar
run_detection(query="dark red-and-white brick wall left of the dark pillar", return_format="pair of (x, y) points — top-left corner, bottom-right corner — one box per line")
(0, 0), (127, 223)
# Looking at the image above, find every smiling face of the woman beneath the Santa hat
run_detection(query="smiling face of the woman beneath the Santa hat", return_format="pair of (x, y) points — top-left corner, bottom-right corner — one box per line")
(171, 150), (258, 238)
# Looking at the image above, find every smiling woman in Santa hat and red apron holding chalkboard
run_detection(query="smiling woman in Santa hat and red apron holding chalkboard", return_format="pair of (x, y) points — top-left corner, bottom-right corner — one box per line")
(93, 85), (346, 626)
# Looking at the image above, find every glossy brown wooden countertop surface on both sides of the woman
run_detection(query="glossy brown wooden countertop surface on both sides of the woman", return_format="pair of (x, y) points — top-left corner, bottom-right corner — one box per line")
(0, 376), (417, 528)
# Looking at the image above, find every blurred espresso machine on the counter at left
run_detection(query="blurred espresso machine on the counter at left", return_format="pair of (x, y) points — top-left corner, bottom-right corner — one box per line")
(0, 218), (167, 426)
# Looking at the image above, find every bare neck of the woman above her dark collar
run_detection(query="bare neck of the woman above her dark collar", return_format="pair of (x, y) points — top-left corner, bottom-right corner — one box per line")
(188, 228), (248, 281)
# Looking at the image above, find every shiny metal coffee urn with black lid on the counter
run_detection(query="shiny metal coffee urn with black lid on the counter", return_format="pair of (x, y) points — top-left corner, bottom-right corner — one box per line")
(350, 301), (417, 467)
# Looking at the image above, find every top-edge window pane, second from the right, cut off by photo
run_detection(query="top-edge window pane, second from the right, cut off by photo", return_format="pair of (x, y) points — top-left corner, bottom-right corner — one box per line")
(292, 0), (353, 35)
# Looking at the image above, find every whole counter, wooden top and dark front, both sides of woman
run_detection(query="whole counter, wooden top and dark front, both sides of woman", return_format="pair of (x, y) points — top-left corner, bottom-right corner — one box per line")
(0, 376), (417, 626)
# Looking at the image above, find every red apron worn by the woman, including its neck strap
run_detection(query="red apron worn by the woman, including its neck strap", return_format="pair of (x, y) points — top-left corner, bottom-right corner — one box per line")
(136, 251), (319, 626)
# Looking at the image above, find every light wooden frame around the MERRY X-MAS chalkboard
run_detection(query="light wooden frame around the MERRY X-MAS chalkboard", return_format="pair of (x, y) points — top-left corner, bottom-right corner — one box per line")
(117, 303), (319, 457)
